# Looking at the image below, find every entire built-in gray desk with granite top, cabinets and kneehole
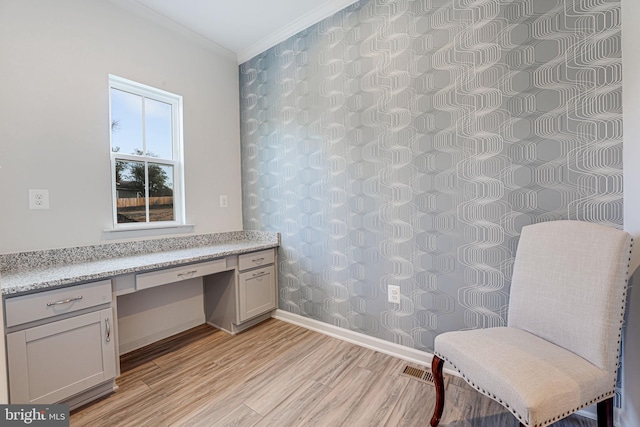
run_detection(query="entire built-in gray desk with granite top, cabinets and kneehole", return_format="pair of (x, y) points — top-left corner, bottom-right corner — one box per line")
(0, 232), (279, 408)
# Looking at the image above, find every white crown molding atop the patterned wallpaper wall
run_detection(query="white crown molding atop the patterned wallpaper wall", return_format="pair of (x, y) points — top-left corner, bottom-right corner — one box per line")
(238, 0), (358, 64)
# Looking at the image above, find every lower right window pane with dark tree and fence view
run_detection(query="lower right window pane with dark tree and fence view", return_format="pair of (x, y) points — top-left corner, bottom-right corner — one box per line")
(149, 163), (175, 222)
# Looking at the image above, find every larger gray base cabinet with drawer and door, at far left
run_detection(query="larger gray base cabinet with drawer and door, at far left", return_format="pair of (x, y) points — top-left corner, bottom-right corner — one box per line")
(6, 281), (116, 404)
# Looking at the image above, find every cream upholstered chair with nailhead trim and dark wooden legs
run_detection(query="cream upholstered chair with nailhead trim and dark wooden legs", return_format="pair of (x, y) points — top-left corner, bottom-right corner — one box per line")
(431, 221), (631, 427)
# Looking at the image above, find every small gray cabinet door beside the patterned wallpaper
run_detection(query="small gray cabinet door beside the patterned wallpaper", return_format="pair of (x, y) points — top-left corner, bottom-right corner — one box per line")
(238, 265), (276, 322)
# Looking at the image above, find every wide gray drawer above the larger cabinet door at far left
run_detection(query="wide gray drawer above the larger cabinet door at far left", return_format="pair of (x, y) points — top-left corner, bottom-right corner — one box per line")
(5, 280), (111, 327)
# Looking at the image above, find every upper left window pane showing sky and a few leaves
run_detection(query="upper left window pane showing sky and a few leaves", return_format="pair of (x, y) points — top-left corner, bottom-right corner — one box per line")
(111, 88), (143, 154)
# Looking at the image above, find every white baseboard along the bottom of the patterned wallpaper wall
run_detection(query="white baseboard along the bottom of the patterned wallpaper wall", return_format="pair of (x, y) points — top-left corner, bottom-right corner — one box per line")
(273, 310), (460, 376)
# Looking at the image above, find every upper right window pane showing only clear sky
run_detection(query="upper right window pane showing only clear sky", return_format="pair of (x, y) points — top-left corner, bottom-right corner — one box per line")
(144, 98), (173, 159)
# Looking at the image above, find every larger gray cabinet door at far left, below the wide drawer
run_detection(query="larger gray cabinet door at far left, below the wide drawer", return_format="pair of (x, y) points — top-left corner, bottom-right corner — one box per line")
(7, 308), (116, 404)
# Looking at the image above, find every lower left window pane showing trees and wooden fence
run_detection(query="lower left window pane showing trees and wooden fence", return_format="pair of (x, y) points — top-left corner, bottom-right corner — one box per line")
(114, 160), (147, 224)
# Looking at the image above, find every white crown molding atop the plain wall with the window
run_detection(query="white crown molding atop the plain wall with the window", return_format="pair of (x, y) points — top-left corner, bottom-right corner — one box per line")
(109, 0), (238, 61)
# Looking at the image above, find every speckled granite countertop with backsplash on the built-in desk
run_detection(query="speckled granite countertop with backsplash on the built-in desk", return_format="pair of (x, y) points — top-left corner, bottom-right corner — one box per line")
(0, 232), (280, 297)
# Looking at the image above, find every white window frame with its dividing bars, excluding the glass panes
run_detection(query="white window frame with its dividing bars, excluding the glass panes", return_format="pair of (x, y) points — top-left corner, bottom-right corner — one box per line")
(109, 74), (185, 231)
